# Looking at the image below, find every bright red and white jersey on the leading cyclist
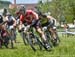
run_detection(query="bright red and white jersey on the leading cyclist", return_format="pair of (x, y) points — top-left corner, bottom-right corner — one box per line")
(20, 10), (39, 24)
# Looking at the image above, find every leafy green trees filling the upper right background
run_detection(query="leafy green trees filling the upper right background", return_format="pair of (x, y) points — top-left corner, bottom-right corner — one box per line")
(37, 0), (75, 22)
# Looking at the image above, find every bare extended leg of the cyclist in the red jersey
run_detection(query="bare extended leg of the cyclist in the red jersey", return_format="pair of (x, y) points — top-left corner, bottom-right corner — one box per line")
(34, 21), (50, 48)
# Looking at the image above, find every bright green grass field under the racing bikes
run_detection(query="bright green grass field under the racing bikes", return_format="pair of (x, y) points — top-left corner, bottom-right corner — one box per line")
(0, 35), (75, 57)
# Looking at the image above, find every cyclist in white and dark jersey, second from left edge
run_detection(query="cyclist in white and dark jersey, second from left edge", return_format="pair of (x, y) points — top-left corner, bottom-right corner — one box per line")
(5, 13), (16, 45)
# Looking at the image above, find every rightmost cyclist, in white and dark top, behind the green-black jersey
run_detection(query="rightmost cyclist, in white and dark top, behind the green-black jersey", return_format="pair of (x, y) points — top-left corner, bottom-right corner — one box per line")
(42, 13), (59, 45)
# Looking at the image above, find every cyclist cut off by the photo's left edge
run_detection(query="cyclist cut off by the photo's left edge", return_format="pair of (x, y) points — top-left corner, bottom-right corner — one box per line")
(0, 12), (8, 48)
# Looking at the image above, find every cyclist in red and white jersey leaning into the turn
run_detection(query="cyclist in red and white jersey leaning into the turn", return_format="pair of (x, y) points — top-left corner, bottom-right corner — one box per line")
(17, 7), (49, 48)
